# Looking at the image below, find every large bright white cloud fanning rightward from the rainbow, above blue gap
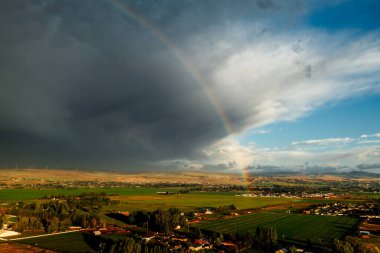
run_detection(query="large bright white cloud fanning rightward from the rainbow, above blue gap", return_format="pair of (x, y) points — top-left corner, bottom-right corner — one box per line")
(188, 28), (380, 133)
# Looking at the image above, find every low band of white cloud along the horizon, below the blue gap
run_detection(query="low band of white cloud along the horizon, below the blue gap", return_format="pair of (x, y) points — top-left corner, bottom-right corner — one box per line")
(157, 134), (380, 172)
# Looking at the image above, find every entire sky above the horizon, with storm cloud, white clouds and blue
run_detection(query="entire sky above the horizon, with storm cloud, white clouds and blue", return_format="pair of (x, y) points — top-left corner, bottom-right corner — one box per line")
(0, 0), (380, 173)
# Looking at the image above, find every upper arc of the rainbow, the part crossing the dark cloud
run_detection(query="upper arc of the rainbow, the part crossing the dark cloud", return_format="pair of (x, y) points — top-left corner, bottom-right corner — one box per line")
(110, 0), (234, 135)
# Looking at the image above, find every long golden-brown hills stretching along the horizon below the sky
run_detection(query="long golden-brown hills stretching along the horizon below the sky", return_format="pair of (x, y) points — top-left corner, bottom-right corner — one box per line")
(0, 169), (380, 186)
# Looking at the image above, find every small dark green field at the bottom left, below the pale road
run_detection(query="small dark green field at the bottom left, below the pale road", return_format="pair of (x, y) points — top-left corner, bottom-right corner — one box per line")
(17, 232), (96, 252)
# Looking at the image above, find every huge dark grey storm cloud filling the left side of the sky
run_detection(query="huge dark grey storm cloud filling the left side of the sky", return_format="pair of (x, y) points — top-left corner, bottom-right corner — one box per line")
(0, 0), (302, 168)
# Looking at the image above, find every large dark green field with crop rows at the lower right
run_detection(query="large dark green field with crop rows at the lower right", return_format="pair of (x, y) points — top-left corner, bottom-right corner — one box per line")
(198, 212), (358, 244)
